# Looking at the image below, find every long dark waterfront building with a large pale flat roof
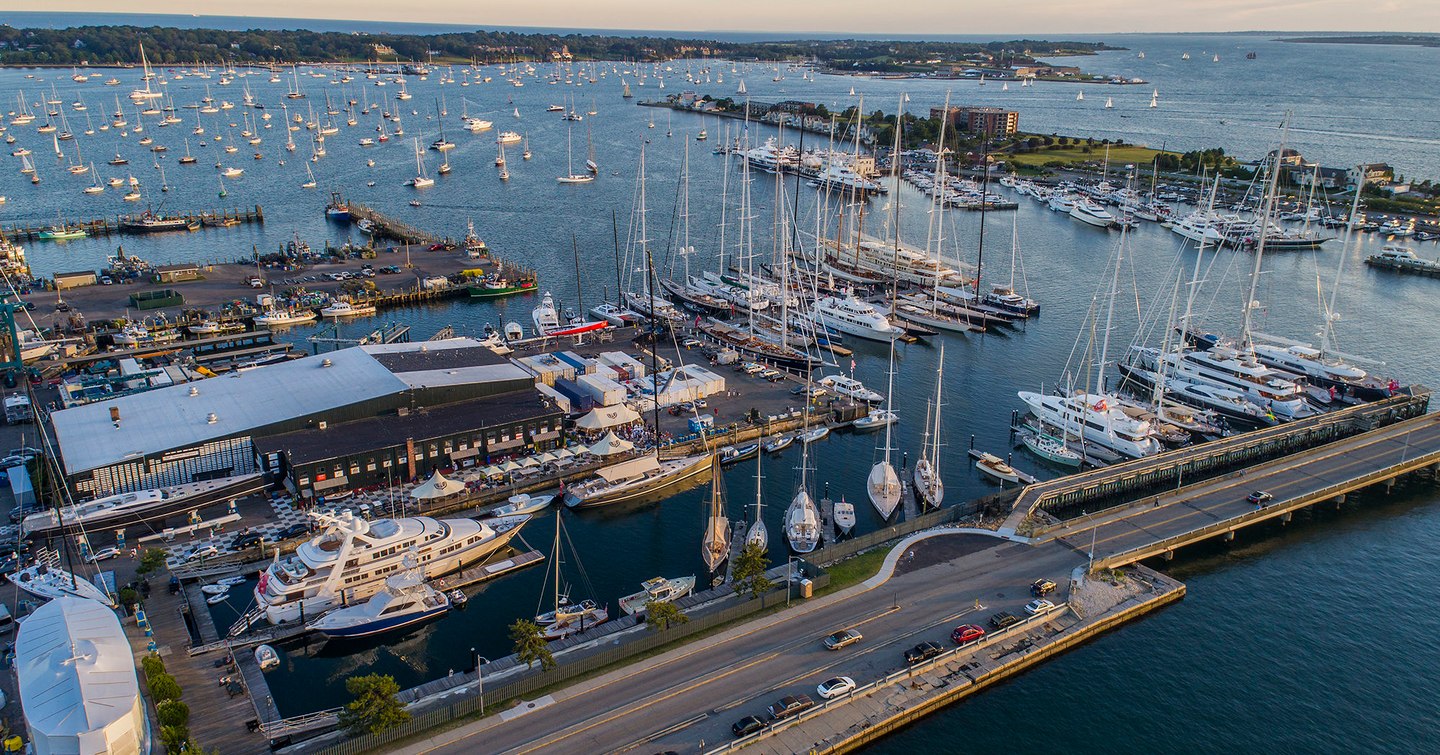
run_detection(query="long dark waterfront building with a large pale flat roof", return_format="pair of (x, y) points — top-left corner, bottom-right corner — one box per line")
(50, 339), (550, 497)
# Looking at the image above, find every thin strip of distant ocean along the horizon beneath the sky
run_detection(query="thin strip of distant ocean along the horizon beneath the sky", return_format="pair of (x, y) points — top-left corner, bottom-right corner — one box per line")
(4, 10), (1416, 42)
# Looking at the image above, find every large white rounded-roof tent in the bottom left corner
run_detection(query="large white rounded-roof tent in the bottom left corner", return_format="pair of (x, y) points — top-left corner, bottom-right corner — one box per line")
(14, 597), (148, 755)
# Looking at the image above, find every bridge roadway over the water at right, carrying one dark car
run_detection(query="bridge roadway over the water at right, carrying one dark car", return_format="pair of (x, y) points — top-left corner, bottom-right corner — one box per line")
(1048, 414), (1440, 559)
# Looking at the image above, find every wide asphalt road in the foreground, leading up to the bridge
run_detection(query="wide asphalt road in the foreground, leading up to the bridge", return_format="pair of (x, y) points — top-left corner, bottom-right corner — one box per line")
(410, 535), (1084, 754)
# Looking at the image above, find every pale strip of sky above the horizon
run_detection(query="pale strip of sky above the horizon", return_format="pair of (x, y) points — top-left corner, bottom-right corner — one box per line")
(11, 0), (1440, 36)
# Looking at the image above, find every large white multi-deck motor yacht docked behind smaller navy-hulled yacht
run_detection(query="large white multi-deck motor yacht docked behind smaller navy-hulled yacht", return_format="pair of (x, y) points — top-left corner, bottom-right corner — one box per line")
(247, 510), (530, 631)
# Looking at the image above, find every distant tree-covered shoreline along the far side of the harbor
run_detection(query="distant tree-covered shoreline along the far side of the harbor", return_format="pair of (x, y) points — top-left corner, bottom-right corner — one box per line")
(0, 26), (1117, 73)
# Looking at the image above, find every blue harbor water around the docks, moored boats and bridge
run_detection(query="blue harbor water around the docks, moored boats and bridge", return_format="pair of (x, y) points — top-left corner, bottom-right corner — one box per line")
(0, 28), (1440, 752)
